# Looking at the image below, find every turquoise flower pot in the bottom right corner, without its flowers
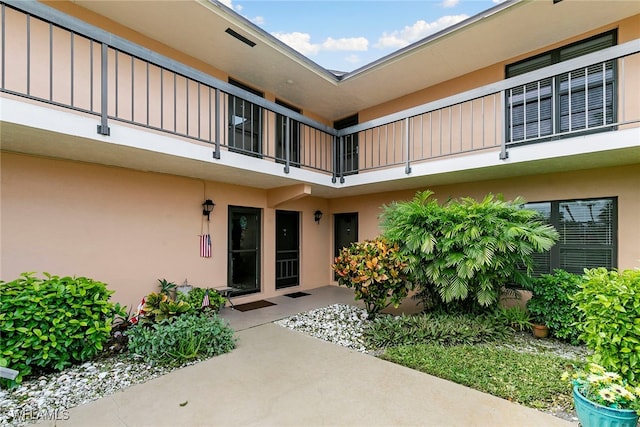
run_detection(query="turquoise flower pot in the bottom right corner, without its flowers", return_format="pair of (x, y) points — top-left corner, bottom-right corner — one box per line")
(573, 387), (638, 427)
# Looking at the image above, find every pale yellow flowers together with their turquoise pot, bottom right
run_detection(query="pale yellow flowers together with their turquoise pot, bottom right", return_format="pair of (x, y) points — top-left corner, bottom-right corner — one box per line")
(564, 363), (640, 427)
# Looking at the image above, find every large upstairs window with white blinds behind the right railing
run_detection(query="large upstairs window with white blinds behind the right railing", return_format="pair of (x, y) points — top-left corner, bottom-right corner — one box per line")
(506, 31), (617, 143)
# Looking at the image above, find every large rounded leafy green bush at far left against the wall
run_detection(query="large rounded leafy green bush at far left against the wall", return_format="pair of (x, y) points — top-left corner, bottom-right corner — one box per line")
(0, 273), (125, 386)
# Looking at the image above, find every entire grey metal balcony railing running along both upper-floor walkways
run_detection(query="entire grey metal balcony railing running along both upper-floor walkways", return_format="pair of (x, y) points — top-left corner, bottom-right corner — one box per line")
(0, 0), (640, 186)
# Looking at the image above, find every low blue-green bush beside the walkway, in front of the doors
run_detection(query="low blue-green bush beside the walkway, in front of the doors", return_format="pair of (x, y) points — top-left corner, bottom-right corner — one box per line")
(128, 313), (235, 365)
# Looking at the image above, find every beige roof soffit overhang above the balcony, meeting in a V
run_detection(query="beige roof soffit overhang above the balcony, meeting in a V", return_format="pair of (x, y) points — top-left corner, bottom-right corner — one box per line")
(72, 0), (640, 120)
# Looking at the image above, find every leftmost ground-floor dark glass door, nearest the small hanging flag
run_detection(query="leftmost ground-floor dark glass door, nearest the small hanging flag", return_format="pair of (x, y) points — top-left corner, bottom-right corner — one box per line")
(227, 206), (260, 295)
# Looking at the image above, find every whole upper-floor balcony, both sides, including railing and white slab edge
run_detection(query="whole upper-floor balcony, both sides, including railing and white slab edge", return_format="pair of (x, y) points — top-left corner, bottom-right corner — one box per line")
(0, 2), (640, 196)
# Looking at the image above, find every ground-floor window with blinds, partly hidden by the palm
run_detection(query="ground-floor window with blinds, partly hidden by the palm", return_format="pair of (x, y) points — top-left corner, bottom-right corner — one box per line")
(524, 197), (618, 276)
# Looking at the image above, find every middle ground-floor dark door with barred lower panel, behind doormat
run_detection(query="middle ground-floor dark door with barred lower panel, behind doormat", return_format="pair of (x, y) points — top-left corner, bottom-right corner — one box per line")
(276, 211), (300, 289)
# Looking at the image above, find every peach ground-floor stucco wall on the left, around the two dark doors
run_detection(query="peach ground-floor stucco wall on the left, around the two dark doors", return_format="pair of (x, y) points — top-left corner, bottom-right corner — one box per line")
(0, 153), (330, 305)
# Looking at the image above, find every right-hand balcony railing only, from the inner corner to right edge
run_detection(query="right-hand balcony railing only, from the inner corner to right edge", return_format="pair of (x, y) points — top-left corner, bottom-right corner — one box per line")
(336, 40), (640, 180)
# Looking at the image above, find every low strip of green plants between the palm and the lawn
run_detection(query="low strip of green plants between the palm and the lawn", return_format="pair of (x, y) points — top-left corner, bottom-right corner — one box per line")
(364, 313), (510, 348)
